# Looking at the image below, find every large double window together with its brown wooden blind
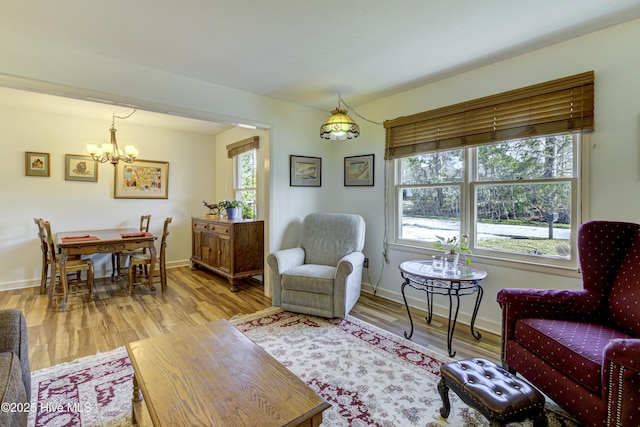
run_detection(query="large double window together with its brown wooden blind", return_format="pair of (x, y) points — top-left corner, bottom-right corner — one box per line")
(384, 71), (595, 268)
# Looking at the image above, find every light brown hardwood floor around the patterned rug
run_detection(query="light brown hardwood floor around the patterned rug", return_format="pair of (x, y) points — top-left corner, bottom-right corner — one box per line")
(0, 267), (500, 371)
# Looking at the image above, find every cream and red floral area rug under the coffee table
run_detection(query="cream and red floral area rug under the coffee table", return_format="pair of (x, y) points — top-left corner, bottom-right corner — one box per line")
(29, 308), (578, 427)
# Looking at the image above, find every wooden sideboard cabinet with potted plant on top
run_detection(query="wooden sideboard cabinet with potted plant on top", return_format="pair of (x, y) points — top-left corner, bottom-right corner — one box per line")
(191, 216), (264, 292)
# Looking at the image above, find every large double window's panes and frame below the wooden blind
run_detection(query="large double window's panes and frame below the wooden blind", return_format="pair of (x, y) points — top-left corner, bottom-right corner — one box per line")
(395, 133), (580, 266)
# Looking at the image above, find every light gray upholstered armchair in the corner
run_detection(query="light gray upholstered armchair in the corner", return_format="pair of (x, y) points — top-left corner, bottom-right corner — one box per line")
(267, 213), (365, 318)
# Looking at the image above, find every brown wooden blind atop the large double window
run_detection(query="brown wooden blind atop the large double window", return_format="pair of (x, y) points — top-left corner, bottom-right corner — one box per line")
(384, 71), (595, 159)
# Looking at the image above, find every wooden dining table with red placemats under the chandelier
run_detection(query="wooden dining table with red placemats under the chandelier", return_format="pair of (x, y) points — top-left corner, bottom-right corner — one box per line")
(56, 228), (156, 311)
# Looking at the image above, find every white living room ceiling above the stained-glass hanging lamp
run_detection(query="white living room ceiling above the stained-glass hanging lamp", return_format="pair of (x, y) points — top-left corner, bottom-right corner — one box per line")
(0, 0), (640, 134)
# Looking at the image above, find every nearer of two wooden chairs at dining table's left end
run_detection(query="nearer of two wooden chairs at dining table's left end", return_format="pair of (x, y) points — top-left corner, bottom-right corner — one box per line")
(37, 218), (94, 311)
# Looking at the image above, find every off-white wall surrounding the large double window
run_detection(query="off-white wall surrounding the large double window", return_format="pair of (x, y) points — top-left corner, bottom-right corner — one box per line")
(335, 20), (640, 332)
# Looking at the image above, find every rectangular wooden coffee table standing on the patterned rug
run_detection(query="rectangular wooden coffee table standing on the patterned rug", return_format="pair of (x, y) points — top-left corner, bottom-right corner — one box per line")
(126, 320), (331, 427)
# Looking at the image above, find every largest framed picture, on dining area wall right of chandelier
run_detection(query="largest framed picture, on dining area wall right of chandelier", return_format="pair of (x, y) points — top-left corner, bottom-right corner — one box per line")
(113, 160), (169, 199)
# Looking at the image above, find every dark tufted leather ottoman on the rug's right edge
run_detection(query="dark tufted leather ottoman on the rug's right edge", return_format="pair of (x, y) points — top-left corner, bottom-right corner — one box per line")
(438, 358), (547, 427)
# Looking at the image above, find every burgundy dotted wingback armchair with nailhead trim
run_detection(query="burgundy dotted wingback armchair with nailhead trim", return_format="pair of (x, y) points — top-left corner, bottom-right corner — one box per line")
(497, 221), (640, 427)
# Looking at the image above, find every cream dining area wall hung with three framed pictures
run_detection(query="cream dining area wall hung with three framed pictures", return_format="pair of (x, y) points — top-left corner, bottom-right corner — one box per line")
(0, 102), (215, 289)
